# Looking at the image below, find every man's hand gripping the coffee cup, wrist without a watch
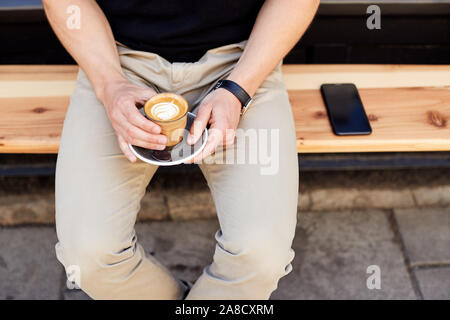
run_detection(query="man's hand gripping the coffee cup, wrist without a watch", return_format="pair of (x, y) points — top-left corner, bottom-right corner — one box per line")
(101, 80), (167, 162)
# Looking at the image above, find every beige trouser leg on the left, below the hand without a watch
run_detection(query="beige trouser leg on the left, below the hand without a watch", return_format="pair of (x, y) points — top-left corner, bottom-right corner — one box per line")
(55, 72), (183, 299)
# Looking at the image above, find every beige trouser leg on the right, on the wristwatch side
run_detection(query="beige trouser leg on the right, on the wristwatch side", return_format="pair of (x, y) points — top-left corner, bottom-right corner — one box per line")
(187, 63), (298, 299)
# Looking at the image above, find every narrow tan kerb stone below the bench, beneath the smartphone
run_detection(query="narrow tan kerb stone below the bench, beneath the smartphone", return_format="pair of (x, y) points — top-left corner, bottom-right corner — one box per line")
(310, 188), (415, 211)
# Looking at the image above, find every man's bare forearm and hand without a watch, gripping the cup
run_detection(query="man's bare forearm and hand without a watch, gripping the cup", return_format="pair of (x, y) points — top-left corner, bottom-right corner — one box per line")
(43, 0), (167, 162)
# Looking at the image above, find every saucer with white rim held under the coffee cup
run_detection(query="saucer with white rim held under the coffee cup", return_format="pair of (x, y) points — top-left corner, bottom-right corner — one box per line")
(129, 112), (208, 166)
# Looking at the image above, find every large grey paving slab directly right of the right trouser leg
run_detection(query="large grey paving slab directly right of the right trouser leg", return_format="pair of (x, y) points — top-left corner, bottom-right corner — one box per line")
(272, 210), (416, 299)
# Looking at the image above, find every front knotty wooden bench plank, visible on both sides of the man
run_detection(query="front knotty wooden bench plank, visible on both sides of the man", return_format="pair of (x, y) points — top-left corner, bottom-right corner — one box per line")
(0, 87), (450, 153)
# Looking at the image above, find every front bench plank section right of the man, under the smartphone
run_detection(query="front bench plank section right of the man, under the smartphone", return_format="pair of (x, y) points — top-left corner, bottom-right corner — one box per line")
(290, 87), (450, 153)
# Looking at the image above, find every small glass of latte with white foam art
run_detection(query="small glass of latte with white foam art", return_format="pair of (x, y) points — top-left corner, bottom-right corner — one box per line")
(144, 93), (189, 150)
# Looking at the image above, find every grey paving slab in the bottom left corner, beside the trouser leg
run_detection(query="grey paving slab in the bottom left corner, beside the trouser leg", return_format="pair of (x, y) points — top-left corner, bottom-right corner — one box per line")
(0, 227), (63, 300)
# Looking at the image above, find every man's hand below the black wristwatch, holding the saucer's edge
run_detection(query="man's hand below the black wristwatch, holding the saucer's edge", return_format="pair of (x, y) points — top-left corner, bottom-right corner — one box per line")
(187, 88), (241, 163)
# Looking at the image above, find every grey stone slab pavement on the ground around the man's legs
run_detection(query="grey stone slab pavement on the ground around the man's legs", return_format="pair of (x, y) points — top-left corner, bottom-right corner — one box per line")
(0, 207), (450, 299)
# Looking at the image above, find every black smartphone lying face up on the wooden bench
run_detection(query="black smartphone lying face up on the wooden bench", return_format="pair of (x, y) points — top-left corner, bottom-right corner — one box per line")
(320, 83), (372, 136)
